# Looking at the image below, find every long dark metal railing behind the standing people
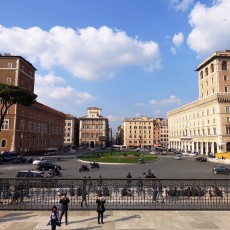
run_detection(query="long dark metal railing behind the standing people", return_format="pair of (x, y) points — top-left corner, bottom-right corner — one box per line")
(0, 178), (230, 210)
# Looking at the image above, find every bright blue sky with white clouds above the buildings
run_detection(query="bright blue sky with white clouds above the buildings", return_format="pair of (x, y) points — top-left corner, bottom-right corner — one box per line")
(0, 0), (230, 133)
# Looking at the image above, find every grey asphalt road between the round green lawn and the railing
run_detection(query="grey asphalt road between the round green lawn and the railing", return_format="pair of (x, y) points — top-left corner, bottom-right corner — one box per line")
(0, 152), (230, 179)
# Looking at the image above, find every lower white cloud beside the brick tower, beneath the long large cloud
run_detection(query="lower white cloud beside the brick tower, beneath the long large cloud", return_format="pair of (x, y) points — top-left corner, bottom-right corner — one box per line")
(35, 73), (95, 107)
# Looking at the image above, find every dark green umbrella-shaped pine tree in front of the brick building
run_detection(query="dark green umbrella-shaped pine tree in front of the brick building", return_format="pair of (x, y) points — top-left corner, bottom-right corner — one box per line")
(0, 84), (37, 131)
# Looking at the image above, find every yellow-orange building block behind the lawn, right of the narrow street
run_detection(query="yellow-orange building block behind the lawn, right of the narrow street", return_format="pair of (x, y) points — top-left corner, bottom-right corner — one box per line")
(123, 116), (167, 148)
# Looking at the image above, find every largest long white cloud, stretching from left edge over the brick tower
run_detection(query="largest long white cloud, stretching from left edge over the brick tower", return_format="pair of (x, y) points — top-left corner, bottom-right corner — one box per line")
(0, 25), (161, 80)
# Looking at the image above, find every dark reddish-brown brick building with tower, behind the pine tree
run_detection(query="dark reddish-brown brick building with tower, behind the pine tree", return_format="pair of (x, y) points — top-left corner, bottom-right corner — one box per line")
(0, 54), (65, 152)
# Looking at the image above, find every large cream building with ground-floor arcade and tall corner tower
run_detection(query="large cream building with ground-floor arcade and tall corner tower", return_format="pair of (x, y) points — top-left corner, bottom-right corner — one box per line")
(167, 50), (230, 154)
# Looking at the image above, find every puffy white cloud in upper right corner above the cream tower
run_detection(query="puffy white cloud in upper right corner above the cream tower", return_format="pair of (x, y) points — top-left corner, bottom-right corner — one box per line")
(187, 0), (230, 56)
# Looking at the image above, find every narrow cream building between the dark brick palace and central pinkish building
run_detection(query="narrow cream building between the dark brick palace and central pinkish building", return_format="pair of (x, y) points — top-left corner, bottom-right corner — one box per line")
(64, 114), (79, 146)
